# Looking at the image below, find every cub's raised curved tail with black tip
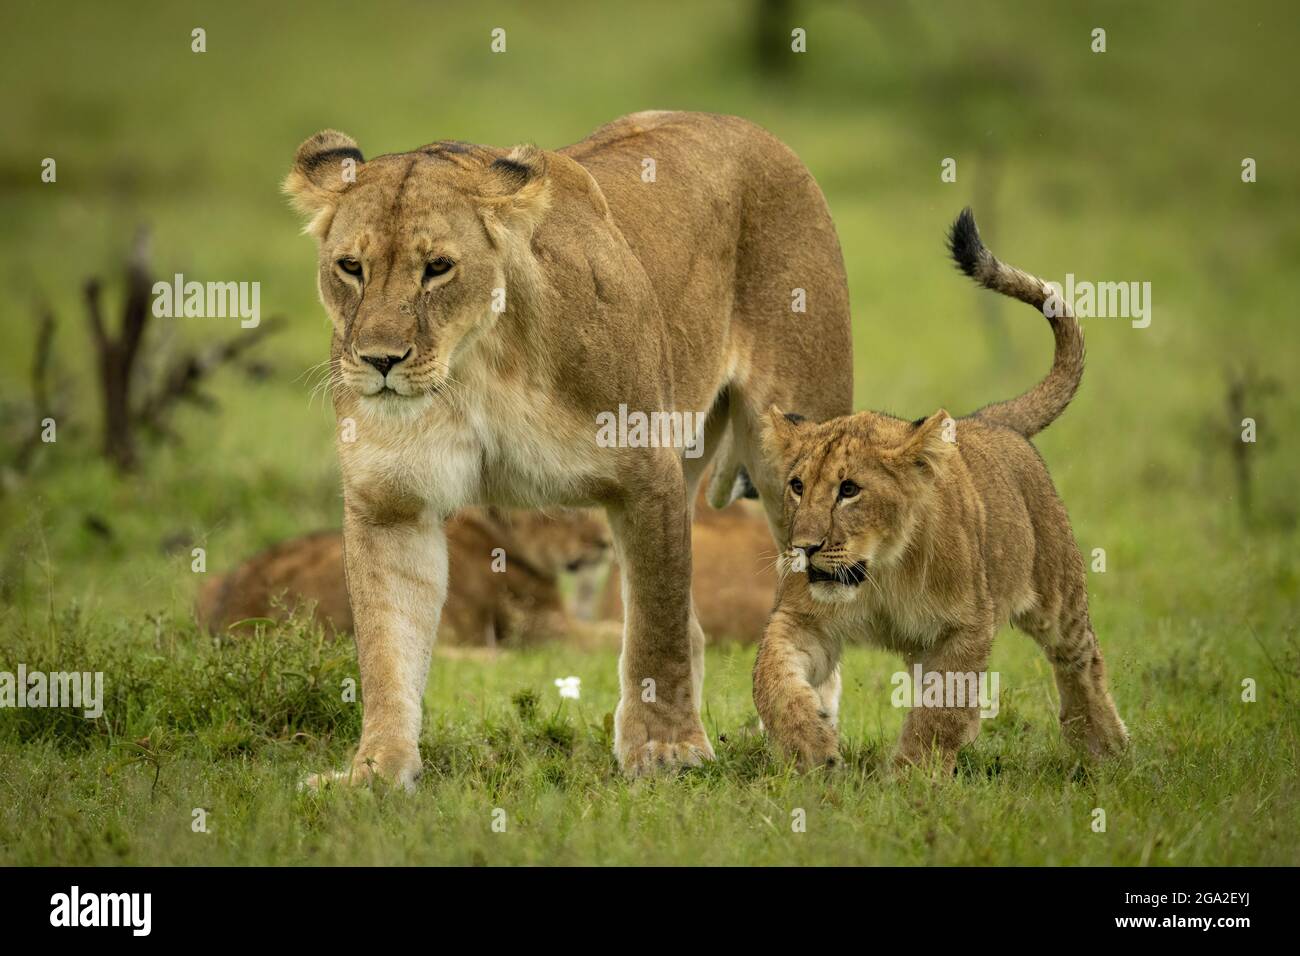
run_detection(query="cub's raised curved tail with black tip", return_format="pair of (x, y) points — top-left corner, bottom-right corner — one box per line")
(948, 208), (1083, 438)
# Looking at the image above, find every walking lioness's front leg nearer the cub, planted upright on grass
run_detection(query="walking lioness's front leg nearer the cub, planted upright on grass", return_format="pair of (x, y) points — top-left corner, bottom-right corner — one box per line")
(610, 455), (714, 777)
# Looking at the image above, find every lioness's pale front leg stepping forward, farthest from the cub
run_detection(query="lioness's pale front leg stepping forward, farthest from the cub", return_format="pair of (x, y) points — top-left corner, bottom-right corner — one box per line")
(307, 503), (447, 790)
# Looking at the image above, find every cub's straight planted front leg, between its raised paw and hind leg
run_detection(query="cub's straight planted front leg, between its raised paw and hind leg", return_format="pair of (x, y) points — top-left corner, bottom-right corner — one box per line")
(894, 623), (996, 777)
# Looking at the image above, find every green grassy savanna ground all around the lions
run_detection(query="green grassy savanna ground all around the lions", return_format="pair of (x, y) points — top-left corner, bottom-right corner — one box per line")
(0, 3), (1300, 865)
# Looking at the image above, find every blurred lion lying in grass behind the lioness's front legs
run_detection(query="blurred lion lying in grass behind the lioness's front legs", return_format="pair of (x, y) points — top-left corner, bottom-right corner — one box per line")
(195, 507), (610, 646)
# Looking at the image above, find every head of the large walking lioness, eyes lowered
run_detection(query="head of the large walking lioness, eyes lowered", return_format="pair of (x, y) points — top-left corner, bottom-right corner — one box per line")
(285, 130), (549, 407)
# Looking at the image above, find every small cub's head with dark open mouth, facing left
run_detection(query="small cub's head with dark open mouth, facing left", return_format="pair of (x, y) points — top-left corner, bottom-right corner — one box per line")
(763, 408), (956, 602)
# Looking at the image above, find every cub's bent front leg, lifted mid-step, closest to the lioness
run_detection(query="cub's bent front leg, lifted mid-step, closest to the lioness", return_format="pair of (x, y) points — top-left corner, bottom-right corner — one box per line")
(754, 605), (840, 770)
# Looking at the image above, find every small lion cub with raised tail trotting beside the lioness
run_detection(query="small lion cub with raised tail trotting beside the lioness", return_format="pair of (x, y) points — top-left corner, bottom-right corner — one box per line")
(754, 209), (1127, 773)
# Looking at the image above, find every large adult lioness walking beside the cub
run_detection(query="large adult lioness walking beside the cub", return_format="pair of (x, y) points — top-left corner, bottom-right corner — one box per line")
(285, 112), (853, 787)
